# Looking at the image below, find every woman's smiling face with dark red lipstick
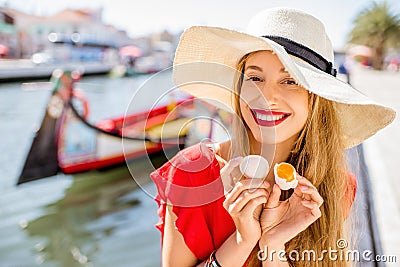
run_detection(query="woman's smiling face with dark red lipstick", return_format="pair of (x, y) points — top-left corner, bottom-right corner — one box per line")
(240, 51), (308, 144)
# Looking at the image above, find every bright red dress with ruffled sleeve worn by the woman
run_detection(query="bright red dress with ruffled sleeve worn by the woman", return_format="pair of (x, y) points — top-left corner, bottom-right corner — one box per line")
(150, 144), (355, 266)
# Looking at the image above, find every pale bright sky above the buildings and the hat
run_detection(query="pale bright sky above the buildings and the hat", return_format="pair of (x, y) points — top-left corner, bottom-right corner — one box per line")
(0, 0), (400, 48)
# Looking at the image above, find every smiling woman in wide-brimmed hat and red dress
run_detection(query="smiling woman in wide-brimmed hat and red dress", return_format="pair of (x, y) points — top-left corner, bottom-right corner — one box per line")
(151, 8), (395, 266)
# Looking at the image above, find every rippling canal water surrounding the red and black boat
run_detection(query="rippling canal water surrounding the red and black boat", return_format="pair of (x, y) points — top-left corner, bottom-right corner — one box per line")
(0, 73), (173, 267)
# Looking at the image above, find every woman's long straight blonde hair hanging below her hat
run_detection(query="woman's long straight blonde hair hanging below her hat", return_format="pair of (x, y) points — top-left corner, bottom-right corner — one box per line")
(232, 54), (349, 267)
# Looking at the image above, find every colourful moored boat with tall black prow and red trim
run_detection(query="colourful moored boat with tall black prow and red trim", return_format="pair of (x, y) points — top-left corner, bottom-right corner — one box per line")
(17, 70), (194, 184)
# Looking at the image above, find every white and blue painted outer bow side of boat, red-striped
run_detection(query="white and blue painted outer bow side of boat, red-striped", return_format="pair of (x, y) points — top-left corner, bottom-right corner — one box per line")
(57, 108), (179, 174)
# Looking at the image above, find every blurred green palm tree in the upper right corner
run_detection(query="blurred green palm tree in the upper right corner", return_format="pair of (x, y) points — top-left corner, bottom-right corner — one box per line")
(349, 2), (400, 70)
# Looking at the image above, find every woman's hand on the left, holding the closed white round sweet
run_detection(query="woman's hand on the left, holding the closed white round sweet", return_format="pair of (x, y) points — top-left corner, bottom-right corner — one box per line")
(221, 160), (269, 247)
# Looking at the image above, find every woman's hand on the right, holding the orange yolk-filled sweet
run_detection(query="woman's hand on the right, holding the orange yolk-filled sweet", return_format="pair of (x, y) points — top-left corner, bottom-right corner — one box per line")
(260, 174), (324, 248)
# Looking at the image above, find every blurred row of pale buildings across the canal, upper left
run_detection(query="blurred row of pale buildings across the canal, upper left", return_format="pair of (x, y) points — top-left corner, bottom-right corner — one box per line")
(0, 7), (132, 63)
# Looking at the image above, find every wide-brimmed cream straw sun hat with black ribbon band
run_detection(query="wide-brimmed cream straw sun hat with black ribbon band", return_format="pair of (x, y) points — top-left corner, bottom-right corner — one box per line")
(173, 8), (396, 148)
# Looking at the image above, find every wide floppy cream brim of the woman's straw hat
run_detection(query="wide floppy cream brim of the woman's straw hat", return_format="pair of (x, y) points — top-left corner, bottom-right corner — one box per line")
(173, 26), (396, 148)
